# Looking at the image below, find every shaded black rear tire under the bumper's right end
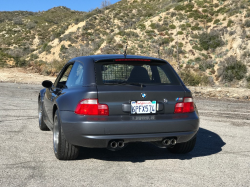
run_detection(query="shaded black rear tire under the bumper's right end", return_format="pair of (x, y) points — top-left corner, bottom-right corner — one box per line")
(168, 135), (196, 154)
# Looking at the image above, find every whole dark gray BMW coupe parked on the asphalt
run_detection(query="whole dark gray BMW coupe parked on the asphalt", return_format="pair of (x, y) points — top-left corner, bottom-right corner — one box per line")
(38, 55), (199, 160)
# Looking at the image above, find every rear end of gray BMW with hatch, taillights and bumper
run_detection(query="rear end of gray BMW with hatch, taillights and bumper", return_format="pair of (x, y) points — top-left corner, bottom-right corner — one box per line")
(61, 57), (199, 149)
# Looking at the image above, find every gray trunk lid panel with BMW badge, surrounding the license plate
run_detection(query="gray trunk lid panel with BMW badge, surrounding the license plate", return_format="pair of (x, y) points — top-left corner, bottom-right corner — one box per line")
(97, 85), (185, 116)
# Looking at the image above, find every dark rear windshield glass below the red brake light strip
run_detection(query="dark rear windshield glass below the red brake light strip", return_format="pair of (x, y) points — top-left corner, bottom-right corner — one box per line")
(95, 62), (180, 85)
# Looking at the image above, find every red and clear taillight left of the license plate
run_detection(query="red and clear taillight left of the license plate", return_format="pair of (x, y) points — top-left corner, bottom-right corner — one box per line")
(75, 99), (109, 116)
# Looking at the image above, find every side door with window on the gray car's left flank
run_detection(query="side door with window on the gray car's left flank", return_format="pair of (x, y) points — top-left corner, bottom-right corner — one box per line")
(44, 62), (74, 125)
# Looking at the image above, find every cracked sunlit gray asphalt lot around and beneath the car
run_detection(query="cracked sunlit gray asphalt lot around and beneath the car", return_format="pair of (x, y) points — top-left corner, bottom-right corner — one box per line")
(0, 83), (250, 187)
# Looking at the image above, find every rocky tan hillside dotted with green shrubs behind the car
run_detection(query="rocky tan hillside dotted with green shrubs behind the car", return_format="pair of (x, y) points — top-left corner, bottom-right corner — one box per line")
(0, 0), (250, 88)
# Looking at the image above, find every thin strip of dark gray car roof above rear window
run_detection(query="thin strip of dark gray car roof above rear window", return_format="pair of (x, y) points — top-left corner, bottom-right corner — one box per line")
(69, 54), (165, 62)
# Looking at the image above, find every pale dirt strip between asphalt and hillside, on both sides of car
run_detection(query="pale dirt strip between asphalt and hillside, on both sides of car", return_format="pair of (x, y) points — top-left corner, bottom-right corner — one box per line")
(0, 68), (250, 101)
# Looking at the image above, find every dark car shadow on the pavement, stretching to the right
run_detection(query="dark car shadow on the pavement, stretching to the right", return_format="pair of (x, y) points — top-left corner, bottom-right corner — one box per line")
(78, 128), (226, 162)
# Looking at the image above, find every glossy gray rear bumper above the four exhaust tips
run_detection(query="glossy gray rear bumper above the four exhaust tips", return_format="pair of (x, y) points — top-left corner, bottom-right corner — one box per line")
(60, 111), (199, 148)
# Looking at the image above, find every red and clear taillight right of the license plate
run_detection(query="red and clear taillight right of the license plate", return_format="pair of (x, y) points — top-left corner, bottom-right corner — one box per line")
(174, 97), (194, 113)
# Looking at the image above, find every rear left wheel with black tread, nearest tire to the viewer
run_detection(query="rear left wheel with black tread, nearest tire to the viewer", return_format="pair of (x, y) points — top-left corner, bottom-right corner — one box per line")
(53, 111), (79, 160)
